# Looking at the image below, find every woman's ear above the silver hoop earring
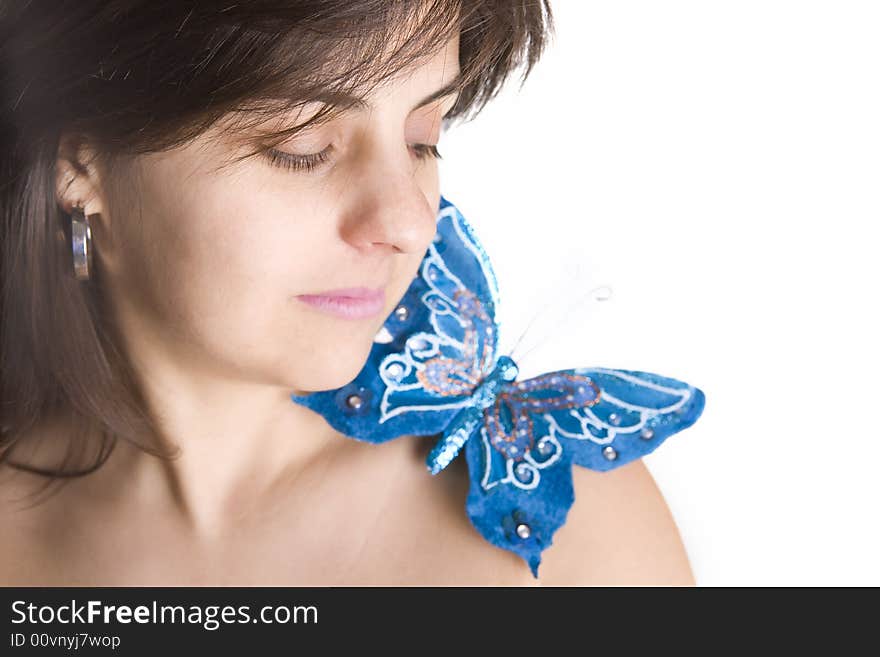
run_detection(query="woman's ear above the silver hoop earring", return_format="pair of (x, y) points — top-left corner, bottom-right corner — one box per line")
(55, 133), (104, 215)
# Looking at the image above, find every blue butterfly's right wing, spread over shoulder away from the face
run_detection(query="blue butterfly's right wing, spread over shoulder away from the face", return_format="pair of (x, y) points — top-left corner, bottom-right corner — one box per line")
(465, 368), (705, 577)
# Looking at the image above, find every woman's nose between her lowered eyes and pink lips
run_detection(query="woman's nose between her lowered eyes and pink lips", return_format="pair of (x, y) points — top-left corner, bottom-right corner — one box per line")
(341, 152), (439, 254)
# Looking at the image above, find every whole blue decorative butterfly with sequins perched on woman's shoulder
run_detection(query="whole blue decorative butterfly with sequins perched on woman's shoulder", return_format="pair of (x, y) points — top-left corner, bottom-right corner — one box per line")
(291, 197), (705, 578)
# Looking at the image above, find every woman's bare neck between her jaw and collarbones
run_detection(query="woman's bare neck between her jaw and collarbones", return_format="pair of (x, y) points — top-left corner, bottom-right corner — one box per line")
(110, 328), (360, 535)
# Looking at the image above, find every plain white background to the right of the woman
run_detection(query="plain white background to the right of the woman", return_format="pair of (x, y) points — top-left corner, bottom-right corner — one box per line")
(440, 0), (880, 586)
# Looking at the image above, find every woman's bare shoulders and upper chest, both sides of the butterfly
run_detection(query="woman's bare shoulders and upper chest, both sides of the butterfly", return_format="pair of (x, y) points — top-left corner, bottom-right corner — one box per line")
(0, 422), (694, 586)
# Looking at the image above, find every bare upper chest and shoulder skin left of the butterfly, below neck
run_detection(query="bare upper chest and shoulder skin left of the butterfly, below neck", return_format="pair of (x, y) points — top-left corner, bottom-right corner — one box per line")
(0, 418), (537, 586)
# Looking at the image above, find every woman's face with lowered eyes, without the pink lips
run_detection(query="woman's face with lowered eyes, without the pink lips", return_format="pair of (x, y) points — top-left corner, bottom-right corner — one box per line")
(95, 38), (459, 392)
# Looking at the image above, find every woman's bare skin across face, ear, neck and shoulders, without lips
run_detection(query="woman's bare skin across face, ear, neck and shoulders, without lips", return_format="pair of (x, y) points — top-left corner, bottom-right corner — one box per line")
(0, 29), (693, 586)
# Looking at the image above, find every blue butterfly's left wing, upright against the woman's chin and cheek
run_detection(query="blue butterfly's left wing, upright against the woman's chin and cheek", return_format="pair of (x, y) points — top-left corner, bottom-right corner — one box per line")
(291, 197), (498, 442)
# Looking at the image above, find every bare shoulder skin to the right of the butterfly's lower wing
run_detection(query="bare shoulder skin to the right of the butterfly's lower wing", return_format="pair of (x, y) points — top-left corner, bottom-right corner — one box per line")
(539, 459), (695, 586)
